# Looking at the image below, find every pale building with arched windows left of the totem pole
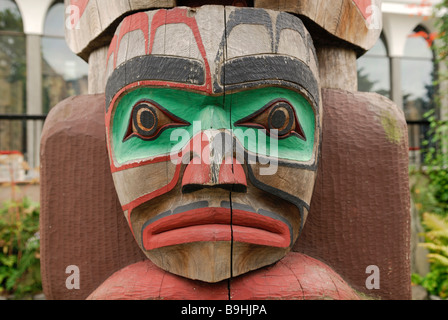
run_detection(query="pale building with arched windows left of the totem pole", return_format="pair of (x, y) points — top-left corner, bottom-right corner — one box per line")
(0, 0), (88, 176)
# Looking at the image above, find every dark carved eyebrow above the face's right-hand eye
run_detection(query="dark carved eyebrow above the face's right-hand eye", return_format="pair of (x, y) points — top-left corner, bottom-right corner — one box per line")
(220, 55), (320, 106)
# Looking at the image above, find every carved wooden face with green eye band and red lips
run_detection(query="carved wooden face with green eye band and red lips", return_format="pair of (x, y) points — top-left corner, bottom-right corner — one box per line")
(106, 6), (322, 282)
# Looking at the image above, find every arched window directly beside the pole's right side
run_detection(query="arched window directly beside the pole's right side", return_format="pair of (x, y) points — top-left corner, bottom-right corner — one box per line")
(358, 35), (391, 98)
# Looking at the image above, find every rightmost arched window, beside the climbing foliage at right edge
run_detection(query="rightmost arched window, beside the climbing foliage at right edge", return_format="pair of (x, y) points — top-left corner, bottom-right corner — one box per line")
(401, 26), (436, 165)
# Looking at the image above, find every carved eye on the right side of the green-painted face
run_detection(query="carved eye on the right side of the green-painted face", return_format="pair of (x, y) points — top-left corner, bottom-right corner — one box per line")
(235, 100), (306, 141)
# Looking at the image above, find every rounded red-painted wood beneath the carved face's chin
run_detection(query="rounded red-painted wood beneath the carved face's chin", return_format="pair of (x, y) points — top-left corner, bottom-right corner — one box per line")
(87, 252), (360, 300)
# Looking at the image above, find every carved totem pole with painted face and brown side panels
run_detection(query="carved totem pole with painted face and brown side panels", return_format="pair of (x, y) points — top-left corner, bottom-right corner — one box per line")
(41, 0), (410, 300)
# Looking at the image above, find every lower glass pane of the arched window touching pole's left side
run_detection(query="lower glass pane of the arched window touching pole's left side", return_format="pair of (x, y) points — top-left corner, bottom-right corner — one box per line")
(42, 37), (89, 113)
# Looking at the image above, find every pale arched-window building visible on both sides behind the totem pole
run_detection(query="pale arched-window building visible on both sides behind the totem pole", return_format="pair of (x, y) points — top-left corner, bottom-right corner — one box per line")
(0, 0), (446, 178)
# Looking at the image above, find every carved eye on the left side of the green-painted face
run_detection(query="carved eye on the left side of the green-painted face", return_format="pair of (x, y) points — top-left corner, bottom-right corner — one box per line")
(123, 101), (190, 141)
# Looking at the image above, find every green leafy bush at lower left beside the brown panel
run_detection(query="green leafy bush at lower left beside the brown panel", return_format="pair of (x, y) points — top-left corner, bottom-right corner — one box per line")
(0, 198), (42, 298)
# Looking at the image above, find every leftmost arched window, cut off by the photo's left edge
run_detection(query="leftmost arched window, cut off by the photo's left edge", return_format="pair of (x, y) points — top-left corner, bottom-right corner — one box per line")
(0, 0), (26, 151)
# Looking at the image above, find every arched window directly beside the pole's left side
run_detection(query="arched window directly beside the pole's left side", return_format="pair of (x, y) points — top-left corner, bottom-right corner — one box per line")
(42, 1), (88, 113)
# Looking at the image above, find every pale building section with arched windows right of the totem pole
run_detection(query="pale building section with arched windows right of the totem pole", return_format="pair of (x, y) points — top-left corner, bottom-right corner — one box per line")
(358, 0), (447, 165)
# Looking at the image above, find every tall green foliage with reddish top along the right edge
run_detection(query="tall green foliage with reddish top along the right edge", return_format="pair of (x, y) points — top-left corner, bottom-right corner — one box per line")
(411, 0), (448, 299)
